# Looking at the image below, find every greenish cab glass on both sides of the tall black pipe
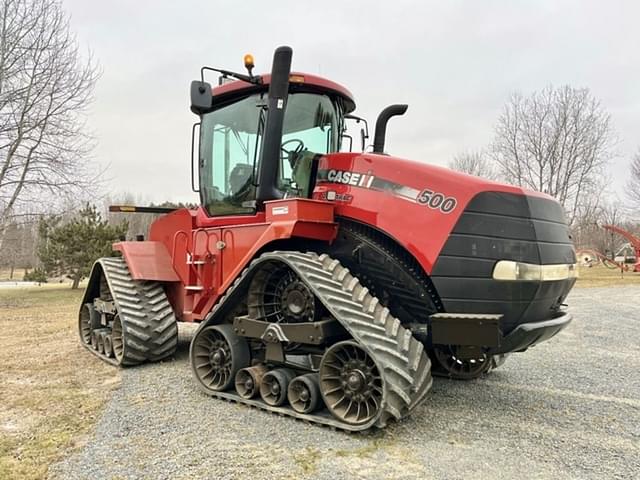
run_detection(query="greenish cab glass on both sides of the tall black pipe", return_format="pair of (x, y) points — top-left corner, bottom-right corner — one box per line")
(200, 93), (340, 215)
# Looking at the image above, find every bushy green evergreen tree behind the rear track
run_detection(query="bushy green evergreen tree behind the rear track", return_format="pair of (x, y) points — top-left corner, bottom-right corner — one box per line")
(38, 205), (127, 288)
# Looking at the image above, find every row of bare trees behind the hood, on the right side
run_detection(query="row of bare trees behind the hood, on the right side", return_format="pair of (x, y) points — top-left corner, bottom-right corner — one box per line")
(449, 85), (640, 251)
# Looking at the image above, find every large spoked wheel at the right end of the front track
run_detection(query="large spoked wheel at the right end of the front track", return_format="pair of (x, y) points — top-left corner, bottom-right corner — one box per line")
(319, 340), (383, 425)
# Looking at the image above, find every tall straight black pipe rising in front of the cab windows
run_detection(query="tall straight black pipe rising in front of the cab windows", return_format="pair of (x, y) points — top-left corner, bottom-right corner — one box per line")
(256, 47), (293, 203)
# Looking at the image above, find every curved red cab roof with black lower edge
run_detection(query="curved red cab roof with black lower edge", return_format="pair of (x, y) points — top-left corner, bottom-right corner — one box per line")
(212, 72), (356, 113)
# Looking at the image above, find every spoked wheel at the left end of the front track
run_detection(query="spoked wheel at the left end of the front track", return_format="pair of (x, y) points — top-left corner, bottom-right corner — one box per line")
(191, 324), (251, 392)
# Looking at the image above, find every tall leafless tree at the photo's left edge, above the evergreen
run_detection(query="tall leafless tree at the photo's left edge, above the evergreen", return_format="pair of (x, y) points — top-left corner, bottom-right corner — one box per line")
(0, 0), (98, 228)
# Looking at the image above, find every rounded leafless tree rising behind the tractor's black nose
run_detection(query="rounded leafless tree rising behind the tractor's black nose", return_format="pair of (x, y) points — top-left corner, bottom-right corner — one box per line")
(492, 86), (615, 224)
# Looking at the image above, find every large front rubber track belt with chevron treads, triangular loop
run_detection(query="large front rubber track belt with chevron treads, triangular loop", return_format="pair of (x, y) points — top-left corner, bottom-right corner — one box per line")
(192, 251), (432, 431)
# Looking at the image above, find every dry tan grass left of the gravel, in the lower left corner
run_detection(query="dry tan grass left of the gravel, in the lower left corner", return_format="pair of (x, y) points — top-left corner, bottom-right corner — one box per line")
(0, 285), (120, 479)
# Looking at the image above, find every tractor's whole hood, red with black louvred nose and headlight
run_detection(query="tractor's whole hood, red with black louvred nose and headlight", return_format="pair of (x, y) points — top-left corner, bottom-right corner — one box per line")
(315, 154), (576, 336)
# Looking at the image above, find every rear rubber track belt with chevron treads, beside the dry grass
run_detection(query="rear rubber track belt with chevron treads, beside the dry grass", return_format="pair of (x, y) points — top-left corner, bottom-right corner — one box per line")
(83, 257), (178, 366)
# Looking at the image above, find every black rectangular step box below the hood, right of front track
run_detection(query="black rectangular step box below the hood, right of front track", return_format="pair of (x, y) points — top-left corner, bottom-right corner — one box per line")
(429, 313), (503, 347)
